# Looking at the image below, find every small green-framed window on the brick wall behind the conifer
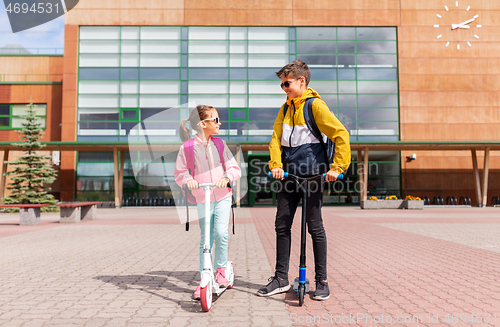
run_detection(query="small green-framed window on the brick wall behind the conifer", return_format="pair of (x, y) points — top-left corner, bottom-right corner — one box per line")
(0, 104), (47, 129)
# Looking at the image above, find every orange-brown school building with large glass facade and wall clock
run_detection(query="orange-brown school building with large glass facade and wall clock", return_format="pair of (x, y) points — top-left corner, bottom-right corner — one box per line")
(0, 0), (500, 205)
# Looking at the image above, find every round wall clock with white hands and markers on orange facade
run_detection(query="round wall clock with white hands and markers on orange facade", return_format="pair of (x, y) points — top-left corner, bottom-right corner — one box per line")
(434, 1), (482, 50)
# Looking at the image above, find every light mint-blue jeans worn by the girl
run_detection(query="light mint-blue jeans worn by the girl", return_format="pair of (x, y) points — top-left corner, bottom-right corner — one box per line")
(197, 197), (232, 274)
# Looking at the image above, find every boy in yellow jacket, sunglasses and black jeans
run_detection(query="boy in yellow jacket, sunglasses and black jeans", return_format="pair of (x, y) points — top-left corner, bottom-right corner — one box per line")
(257, 60), (351, 300)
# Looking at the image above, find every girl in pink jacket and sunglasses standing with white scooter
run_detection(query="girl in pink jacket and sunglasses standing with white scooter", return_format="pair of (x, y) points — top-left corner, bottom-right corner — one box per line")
(174, 105), (241, 300)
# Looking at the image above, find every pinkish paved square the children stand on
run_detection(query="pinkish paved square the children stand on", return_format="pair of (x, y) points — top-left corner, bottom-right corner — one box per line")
(0, 207), (500, 326)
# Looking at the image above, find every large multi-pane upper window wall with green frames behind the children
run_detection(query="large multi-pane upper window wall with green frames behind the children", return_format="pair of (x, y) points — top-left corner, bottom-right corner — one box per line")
(78, 26), (399, 142)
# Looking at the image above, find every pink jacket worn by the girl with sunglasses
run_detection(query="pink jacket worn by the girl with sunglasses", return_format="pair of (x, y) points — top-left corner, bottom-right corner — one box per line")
(174, 135), (241, 203)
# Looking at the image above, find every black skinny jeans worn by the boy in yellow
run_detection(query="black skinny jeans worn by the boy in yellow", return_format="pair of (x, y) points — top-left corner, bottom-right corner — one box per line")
(275, 178), (327, 281)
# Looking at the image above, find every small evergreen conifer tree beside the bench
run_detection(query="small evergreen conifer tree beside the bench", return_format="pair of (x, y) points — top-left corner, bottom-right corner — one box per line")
(3, 101), (57, 211)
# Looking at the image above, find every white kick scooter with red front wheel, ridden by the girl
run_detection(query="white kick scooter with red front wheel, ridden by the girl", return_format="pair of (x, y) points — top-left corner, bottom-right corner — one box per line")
(195, 183), (234, 312)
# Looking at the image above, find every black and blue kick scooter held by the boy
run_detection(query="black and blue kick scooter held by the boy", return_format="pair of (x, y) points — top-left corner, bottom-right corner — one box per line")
(268, 172), (344, 306)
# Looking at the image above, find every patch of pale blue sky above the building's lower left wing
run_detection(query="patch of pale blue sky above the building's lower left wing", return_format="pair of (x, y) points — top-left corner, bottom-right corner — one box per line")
(0, 1), (64, 54)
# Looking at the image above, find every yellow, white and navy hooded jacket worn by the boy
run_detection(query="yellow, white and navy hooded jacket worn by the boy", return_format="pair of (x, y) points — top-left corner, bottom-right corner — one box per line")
(269, 87), (351, 176)
